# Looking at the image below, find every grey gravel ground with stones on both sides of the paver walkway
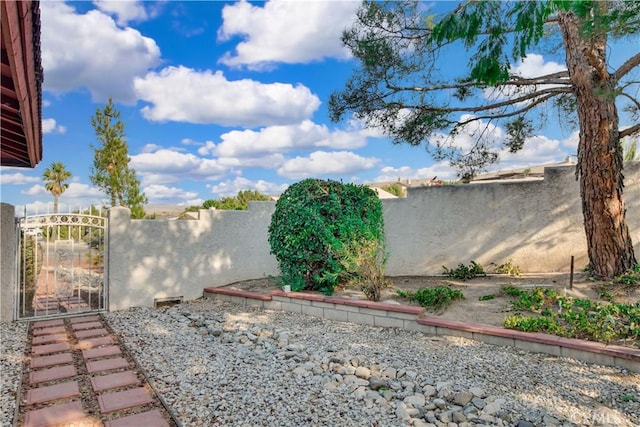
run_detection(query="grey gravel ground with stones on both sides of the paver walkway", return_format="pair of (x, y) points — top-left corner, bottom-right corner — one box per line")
(2, 300), (640, 427)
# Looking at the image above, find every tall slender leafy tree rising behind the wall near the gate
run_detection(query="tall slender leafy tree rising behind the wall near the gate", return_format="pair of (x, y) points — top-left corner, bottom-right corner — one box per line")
(89, 98), (147, 218)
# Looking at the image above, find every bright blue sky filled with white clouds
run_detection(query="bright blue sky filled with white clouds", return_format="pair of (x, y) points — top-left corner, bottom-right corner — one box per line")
(0, 0), (637, 212)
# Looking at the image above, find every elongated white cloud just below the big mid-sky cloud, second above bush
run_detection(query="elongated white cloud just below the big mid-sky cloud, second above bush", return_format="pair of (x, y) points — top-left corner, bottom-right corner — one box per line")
(204, 120), (366, 158)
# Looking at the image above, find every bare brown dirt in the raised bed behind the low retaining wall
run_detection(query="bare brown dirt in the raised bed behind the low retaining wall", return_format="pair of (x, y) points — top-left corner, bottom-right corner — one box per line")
(222, 273), (640, 332)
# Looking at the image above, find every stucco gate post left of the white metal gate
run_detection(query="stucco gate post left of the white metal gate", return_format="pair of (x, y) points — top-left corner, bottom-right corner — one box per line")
(0, 203), (17, 322)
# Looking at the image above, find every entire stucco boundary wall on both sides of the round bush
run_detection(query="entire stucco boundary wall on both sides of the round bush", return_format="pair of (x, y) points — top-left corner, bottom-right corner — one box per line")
(107, 162), (640, 310)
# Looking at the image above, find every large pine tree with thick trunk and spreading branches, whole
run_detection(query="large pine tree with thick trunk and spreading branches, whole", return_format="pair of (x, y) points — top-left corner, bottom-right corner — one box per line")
(329, 1), (640, 278)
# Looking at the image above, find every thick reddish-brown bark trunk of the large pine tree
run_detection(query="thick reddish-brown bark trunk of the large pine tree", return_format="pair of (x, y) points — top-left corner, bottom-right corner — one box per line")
(559, 10), (637, 278)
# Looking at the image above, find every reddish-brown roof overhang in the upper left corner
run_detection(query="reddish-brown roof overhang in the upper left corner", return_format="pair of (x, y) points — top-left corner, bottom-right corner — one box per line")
(0, 0), (43, 168)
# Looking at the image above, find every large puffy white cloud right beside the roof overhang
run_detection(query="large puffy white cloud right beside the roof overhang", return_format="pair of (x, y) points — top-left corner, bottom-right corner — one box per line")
(40, 1), (160, 103)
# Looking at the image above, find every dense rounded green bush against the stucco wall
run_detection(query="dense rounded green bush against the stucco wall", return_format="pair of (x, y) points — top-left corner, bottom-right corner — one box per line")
(269, 179), (384, 295)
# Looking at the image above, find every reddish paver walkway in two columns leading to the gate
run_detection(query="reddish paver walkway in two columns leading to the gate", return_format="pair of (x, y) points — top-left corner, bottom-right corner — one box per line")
(17, 315), (177, 427)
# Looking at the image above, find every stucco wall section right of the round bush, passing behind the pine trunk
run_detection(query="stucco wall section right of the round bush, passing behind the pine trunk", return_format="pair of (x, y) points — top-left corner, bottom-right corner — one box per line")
(384, 162), (640, 275)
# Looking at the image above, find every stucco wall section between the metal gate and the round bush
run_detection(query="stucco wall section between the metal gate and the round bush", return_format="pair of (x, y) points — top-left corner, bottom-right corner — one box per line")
(107, 202), (278, 310)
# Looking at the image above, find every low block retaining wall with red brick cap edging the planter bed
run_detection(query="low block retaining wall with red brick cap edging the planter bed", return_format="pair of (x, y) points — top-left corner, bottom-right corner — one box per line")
(203, 288), (640, 373)
